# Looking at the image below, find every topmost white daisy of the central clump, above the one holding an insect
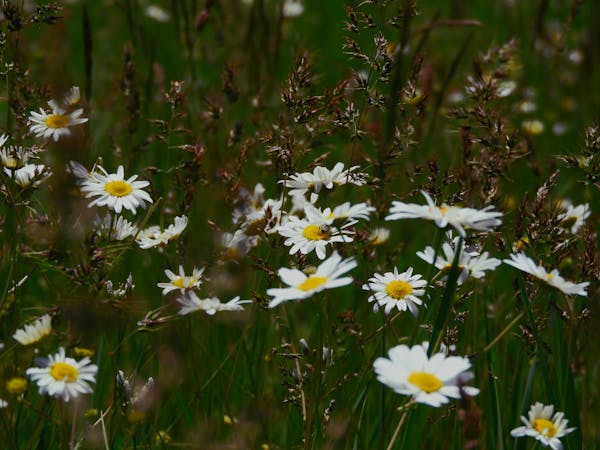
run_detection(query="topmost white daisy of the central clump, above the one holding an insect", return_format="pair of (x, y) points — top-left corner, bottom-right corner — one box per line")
(279, 162), (366, 196)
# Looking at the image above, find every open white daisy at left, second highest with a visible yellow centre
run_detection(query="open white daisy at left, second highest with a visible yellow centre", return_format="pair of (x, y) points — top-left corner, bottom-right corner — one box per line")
(81, 166), (152, 214)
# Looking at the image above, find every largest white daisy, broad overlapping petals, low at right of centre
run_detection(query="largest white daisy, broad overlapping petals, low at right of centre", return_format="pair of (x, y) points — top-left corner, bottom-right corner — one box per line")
(373, 345), (479, 407)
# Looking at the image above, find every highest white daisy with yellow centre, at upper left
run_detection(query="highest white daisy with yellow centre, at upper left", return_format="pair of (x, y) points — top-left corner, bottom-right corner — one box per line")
(29, 100), (87, 141)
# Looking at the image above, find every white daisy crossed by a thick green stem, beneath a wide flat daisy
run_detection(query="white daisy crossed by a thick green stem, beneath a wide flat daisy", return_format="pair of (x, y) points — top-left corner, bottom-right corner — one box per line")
(417, 234), (502, 285)
